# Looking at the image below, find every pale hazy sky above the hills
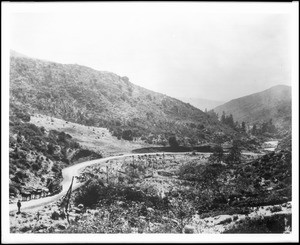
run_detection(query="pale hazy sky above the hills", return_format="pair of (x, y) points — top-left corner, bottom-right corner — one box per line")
(10, 2), (291, 101)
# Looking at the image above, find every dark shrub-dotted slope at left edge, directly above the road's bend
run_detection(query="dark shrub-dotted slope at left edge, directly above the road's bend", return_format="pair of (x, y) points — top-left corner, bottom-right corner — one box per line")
(9, 105), (102, 199)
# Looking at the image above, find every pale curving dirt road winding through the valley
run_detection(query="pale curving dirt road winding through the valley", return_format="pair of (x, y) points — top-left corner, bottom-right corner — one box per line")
(9, 152), (264, 212)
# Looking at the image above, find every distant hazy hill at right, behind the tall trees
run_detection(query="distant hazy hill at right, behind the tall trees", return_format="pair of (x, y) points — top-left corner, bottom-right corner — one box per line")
(214, 85), (291, 129)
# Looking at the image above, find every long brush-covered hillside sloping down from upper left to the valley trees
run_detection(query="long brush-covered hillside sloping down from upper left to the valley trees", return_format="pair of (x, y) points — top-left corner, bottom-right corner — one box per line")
(10, 50), (233, 144)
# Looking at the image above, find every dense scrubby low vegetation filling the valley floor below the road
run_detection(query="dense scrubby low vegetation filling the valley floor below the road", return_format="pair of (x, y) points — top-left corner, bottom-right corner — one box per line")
(54, 148), (291, 233)
